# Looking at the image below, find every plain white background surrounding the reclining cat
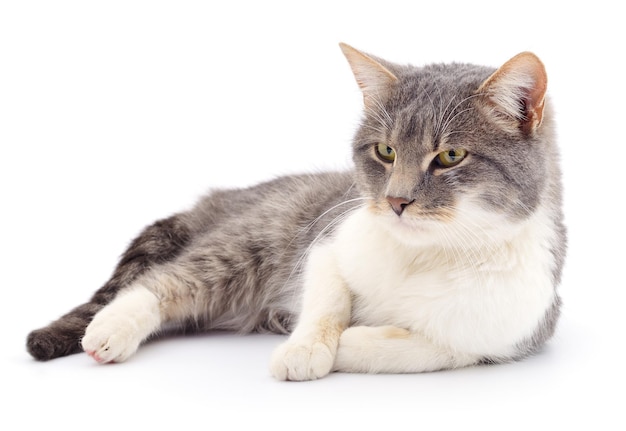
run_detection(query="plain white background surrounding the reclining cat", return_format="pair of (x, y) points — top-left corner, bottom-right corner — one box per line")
(0, 0), (626, 430)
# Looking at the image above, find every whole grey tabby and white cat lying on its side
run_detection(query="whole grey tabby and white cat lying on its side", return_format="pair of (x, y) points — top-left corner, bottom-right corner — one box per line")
(27, 44), (566, 381)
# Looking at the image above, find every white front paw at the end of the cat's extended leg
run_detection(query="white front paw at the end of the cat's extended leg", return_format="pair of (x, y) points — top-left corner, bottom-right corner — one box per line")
(270, 341), (336, 381)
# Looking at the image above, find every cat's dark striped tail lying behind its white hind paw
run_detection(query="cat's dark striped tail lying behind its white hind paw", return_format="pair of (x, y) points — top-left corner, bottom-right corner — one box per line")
(26, 214), (192, 361)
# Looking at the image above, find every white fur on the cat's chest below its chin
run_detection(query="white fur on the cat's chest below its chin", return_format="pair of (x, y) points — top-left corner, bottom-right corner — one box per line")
(328, 209), (554, 356)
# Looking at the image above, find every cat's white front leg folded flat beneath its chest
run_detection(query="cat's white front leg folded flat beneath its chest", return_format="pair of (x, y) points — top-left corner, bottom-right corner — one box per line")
(333, 326), (481, 373)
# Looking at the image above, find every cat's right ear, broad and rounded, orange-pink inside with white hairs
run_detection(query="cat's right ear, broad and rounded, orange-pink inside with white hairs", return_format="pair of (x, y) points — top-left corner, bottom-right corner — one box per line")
(478, 52), (548, 133)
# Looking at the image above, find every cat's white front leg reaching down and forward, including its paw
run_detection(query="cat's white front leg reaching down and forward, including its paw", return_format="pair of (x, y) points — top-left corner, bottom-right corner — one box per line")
(270, 246), (351, 380)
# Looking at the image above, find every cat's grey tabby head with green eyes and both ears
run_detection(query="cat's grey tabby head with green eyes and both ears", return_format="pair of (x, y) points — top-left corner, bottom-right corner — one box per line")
(341, 44), (558, 250)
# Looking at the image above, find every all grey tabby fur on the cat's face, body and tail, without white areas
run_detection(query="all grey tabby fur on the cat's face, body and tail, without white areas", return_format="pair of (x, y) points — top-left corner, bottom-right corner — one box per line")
(27, 46), (565, 361)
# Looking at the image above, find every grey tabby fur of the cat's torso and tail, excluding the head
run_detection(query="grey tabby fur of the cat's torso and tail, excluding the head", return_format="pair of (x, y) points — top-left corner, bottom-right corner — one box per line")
(27, 172), (356, 360)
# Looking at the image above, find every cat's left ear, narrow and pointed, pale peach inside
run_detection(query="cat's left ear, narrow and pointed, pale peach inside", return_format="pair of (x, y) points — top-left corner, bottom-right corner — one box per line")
(339, 43), (398, 107)
